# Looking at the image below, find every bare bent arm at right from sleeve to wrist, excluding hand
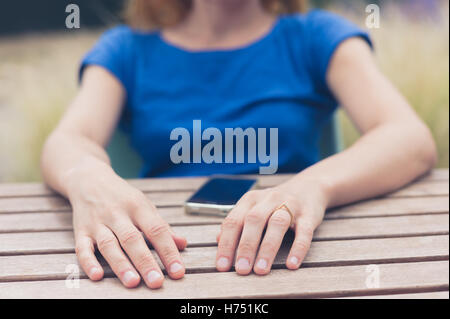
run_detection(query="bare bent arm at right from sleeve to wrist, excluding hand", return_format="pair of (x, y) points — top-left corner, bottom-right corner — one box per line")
(286, 38), (437, 207)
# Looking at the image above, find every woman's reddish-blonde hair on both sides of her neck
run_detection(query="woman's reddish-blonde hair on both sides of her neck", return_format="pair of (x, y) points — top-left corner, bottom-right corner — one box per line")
(125, 0), (307, 29)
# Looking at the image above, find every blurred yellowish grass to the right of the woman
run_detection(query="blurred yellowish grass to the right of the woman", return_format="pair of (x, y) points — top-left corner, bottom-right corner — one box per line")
(339, 2), (449, 168)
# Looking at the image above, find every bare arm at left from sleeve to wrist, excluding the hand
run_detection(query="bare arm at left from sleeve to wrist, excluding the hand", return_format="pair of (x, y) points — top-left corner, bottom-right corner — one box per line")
(41, 67), (121, 198)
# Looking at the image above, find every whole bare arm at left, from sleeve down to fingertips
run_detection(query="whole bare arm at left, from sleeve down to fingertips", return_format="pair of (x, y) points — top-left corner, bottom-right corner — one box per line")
(41, 66), (186, 288)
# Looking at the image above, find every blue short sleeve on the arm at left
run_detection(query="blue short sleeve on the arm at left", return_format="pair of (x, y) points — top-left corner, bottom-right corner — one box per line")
(79, 26), (132, 93)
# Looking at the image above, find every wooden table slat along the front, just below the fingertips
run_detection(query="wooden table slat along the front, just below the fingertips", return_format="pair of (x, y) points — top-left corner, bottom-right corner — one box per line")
(0, 261), (449, 299)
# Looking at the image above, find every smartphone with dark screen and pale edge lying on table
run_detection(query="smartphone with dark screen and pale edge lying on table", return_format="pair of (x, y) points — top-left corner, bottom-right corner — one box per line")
(184, 177), (257, 216)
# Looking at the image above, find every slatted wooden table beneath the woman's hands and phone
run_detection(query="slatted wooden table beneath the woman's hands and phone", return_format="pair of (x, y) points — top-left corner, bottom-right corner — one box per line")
(0, 170), (449, 298)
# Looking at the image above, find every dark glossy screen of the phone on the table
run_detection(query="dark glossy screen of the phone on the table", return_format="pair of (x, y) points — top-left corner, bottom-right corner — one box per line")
(187, 178), (256, 205)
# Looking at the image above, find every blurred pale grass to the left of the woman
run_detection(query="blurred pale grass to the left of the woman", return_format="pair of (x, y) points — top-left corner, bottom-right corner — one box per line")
(0, 32), (99, 182)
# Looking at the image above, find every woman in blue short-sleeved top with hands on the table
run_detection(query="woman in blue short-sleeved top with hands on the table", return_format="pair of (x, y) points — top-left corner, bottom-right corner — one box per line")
(42, 0), (436, 288)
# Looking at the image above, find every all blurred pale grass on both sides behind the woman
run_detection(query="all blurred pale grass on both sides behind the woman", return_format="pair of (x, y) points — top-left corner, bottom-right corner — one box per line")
(0, 2), (449, 182)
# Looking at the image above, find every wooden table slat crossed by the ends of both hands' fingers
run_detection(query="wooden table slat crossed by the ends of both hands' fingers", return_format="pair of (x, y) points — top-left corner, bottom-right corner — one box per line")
(0, 236), (449, 282)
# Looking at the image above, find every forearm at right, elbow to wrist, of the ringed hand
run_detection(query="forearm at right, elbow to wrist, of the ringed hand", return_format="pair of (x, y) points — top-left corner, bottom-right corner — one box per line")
(286, 123), (436, 207)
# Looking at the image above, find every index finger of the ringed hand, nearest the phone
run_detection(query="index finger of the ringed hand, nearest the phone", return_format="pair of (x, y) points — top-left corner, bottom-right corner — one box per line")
(216, 197), (254, 271)
